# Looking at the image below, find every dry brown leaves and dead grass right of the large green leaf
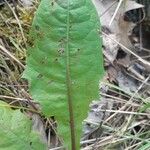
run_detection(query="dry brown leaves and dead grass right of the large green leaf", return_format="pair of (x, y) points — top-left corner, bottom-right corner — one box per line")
(82, 0), (150, 150)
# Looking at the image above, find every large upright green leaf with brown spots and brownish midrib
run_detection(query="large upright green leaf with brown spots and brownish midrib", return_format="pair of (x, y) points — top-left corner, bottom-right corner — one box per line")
(24, 0), (104, 150)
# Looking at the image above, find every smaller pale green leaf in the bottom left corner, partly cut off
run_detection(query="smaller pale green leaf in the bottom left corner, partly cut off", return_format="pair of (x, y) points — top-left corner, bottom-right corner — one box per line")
(0, 101), (46, 150)
